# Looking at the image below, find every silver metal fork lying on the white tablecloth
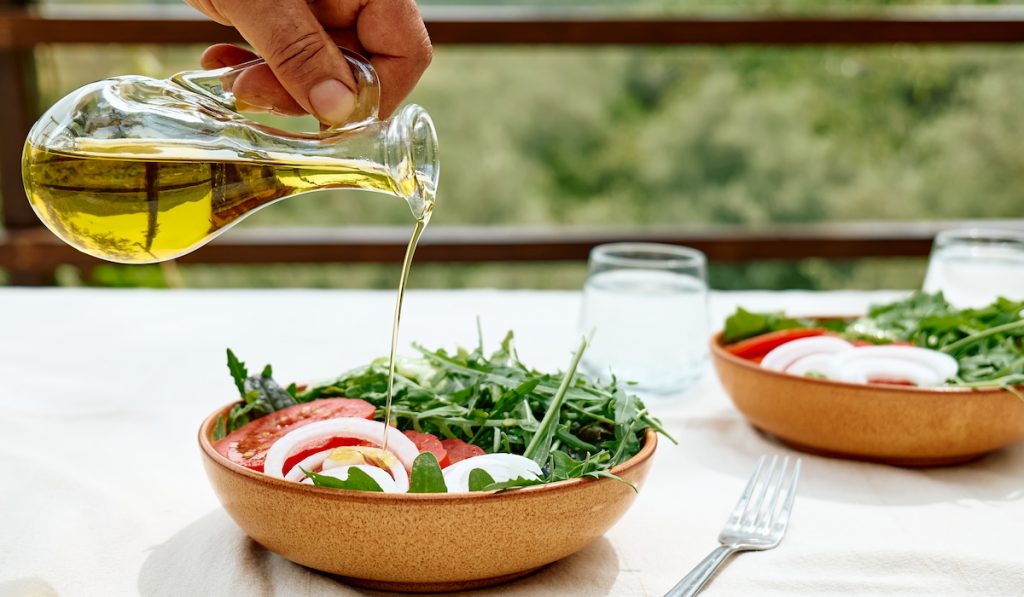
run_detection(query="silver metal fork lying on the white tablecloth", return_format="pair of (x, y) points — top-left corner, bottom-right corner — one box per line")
(665, 455), (801, 597)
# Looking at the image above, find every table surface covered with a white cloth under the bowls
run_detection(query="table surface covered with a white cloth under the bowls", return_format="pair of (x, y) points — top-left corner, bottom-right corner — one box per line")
(0, 289), (1024, 597)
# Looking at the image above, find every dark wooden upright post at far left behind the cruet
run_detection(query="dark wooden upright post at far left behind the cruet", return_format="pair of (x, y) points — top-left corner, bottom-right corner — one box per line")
(0, 0), (53, 286)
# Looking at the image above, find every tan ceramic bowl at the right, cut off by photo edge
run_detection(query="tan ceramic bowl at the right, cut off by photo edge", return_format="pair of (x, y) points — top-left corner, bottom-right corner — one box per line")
(711, 334), (1024, 466)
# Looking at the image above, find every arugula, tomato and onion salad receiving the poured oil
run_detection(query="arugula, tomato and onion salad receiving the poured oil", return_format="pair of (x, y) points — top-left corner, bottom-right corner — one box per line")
(213, 332), (674, 494)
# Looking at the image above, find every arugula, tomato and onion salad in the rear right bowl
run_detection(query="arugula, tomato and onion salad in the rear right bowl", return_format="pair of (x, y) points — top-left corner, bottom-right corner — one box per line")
(723, 292), (1024, 399)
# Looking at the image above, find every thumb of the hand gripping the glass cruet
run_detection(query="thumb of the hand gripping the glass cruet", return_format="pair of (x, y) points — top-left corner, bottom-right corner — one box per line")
(219, 0), (355, 125)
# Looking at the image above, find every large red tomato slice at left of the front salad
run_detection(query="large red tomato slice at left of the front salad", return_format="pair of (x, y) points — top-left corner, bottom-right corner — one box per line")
(213, 398), (376, 472)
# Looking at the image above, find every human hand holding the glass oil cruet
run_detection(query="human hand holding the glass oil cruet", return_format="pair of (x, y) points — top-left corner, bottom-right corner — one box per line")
(185, 0), (431, 125)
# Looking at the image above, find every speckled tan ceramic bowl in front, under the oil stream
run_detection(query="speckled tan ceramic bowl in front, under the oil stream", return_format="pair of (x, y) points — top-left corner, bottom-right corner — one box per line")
(199, 404), (657, 592)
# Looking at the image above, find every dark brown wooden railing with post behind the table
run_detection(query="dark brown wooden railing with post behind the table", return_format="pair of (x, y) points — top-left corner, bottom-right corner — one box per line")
(0, 5), (1024, 284)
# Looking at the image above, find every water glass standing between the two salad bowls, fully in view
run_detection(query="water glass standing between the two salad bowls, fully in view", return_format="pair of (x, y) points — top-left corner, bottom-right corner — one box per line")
(580, 243), (709, 395)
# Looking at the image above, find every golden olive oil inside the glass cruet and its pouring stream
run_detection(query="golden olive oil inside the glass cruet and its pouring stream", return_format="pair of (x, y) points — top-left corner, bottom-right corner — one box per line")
(22, 139), (433, 449)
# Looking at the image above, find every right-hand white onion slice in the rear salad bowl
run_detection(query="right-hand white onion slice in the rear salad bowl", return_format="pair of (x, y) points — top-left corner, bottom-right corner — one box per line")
(828, 346), (959, 386)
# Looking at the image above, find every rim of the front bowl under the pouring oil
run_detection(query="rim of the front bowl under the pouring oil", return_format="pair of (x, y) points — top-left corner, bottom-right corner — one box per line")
(199, 400), (657, 504)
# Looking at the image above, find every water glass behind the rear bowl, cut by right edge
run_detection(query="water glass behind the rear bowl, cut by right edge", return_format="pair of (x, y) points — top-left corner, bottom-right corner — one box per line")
(924, 228), (1024, 308)
